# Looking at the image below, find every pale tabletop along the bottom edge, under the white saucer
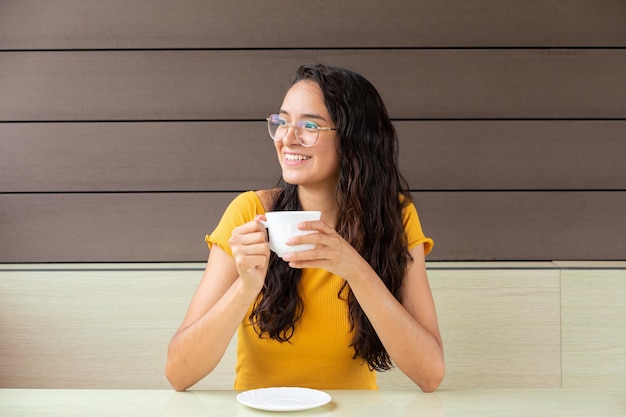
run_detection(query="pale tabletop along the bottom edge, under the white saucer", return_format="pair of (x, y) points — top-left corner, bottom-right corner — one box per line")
(0, 389), (626, 417)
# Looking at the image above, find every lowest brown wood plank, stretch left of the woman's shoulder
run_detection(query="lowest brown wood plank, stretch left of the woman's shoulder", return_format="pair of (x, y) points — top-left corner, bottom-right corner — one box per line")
(0, 193), (233, 262)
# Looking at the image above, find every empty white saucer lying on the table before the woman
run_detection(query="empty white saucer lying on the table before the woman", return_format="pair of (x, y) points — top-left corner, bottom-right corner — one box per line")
(237, 387), (330, 411)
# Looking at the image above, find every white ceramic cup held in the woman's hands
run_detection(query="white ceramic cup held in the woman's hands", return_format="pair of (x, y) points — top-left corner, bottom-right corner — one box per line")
(261, 211), (322, 258)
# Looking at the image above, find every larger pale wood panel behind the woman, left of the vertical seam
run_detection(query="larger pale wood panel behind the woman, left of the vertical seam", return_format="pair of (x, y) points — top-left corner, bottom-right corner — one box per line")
(0, 264), (561, 389)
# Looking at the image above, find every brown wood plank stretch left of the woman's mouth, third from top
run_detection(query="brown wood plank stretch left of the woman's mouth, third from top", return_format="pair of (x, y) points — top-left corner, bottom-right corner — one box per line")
(0, 122), (280, 192)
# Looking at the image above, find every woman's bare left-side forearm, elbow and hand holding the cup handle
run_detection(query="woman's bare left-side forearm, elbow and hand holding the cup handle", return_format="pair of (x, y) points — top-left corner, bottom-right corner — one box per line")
(166, 216), (270, 391)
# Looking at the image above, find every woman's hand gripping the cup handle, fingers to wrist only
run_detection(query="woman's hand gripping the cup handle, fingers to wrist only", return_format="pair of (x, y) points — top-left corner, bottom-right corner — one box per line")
(228, 215), (270, 291)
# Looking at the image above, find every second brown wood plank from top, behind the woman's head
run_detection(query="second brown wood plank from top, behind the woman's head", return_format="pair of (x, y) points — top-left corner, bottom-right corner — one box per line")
(0, 49), (626, 121)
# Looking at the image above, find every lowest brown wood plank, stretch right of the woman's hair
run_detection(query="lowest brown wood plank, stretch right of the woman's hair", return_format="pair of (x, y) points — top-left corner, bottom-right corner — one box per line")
(417, 191), (626, 261)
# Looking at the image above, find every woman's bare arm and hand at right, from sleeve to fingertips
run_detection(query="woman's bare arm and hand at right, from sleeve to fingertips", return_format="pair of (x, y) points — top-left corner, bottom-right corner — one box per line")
(283, 221), (445, 392)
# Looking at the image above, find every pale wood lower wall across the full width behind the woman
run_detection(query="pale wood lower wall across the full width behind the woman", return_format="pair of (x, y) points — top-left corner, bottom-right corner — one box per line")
(0, 261), (626, 407)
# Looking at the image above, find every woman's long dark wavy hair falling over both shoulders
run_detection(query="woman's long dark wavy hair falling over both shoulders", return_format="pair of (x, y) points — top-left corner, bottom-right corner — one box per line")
(249, 64), (413, 371)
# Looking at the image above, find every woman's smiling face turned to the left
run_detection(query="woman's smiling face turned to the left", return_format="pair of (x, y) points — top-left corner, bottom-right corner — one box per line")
(274, 81), (339, 190)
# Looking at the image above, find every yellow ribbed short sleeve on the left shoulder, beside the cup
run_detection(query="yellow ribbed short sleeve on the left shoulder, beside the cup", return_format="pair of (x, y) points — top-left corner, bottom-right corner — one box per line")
(204, 191), (265, 256)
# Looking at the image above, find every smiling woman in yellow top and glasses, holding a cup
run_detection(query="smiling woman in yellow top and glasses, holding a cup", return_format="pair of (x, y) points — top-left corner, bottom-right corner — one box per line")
(166, 65), (444, 391)
